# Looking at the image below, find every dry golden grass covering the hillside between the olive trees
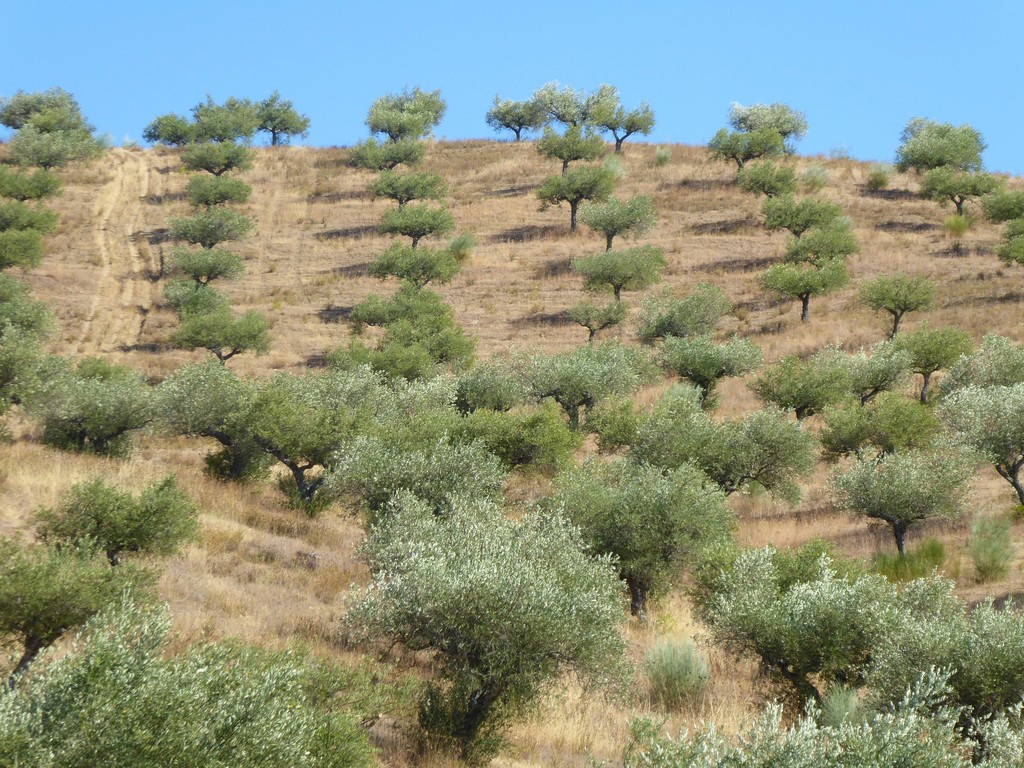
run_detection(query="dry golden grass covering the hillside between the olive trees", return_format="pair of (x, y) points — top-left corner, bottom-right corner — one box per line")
(0, 141), (1024, 766)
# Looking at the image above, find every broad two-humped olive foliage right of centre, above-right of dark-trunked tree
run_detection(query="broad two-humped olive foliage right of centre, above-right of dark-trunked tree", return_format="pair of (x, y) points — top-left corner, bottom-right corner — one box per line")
(630, 386), (817, 502)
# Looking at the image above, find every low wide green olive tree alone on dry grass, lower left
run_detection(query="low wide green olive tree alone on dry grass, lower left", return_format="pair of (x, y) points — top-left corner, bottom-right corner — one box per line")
(36, 475), (199, 566)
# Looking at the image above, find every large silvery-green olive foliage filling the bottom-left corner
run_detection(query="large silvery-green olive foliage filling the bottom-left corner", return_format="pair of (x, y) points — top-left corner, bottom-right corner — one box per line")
(0, 606), (374, 768)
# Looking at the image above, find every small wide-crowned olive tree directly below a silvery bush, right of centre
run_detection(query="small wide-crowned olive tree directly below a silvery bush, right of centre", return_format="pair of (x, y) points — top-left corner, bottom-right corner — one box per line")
(662, 336), (763, 402)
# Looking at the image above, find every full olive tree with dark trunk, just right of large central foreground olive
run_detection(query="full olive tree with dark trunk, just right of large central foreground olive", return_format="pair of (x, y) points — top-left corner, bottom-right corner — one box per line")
(550, 461), (734, 620)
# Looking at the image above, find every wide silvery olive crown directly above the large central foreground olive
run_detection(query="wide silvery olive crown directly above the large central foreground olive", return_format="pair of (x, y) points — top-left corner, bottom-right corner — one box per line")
(328, 435), (506, 515)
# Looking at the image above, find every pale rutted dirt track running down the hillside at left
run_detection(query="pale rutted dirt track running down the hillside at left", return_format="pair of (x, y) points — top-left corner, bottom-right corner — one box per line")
(75, 150), (153, 355)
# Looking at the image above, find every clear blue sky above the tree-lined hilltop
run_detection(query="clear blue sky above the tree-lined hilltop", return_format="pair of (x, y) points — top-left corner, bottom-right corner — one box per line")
(0, 0), (1024, 174)
